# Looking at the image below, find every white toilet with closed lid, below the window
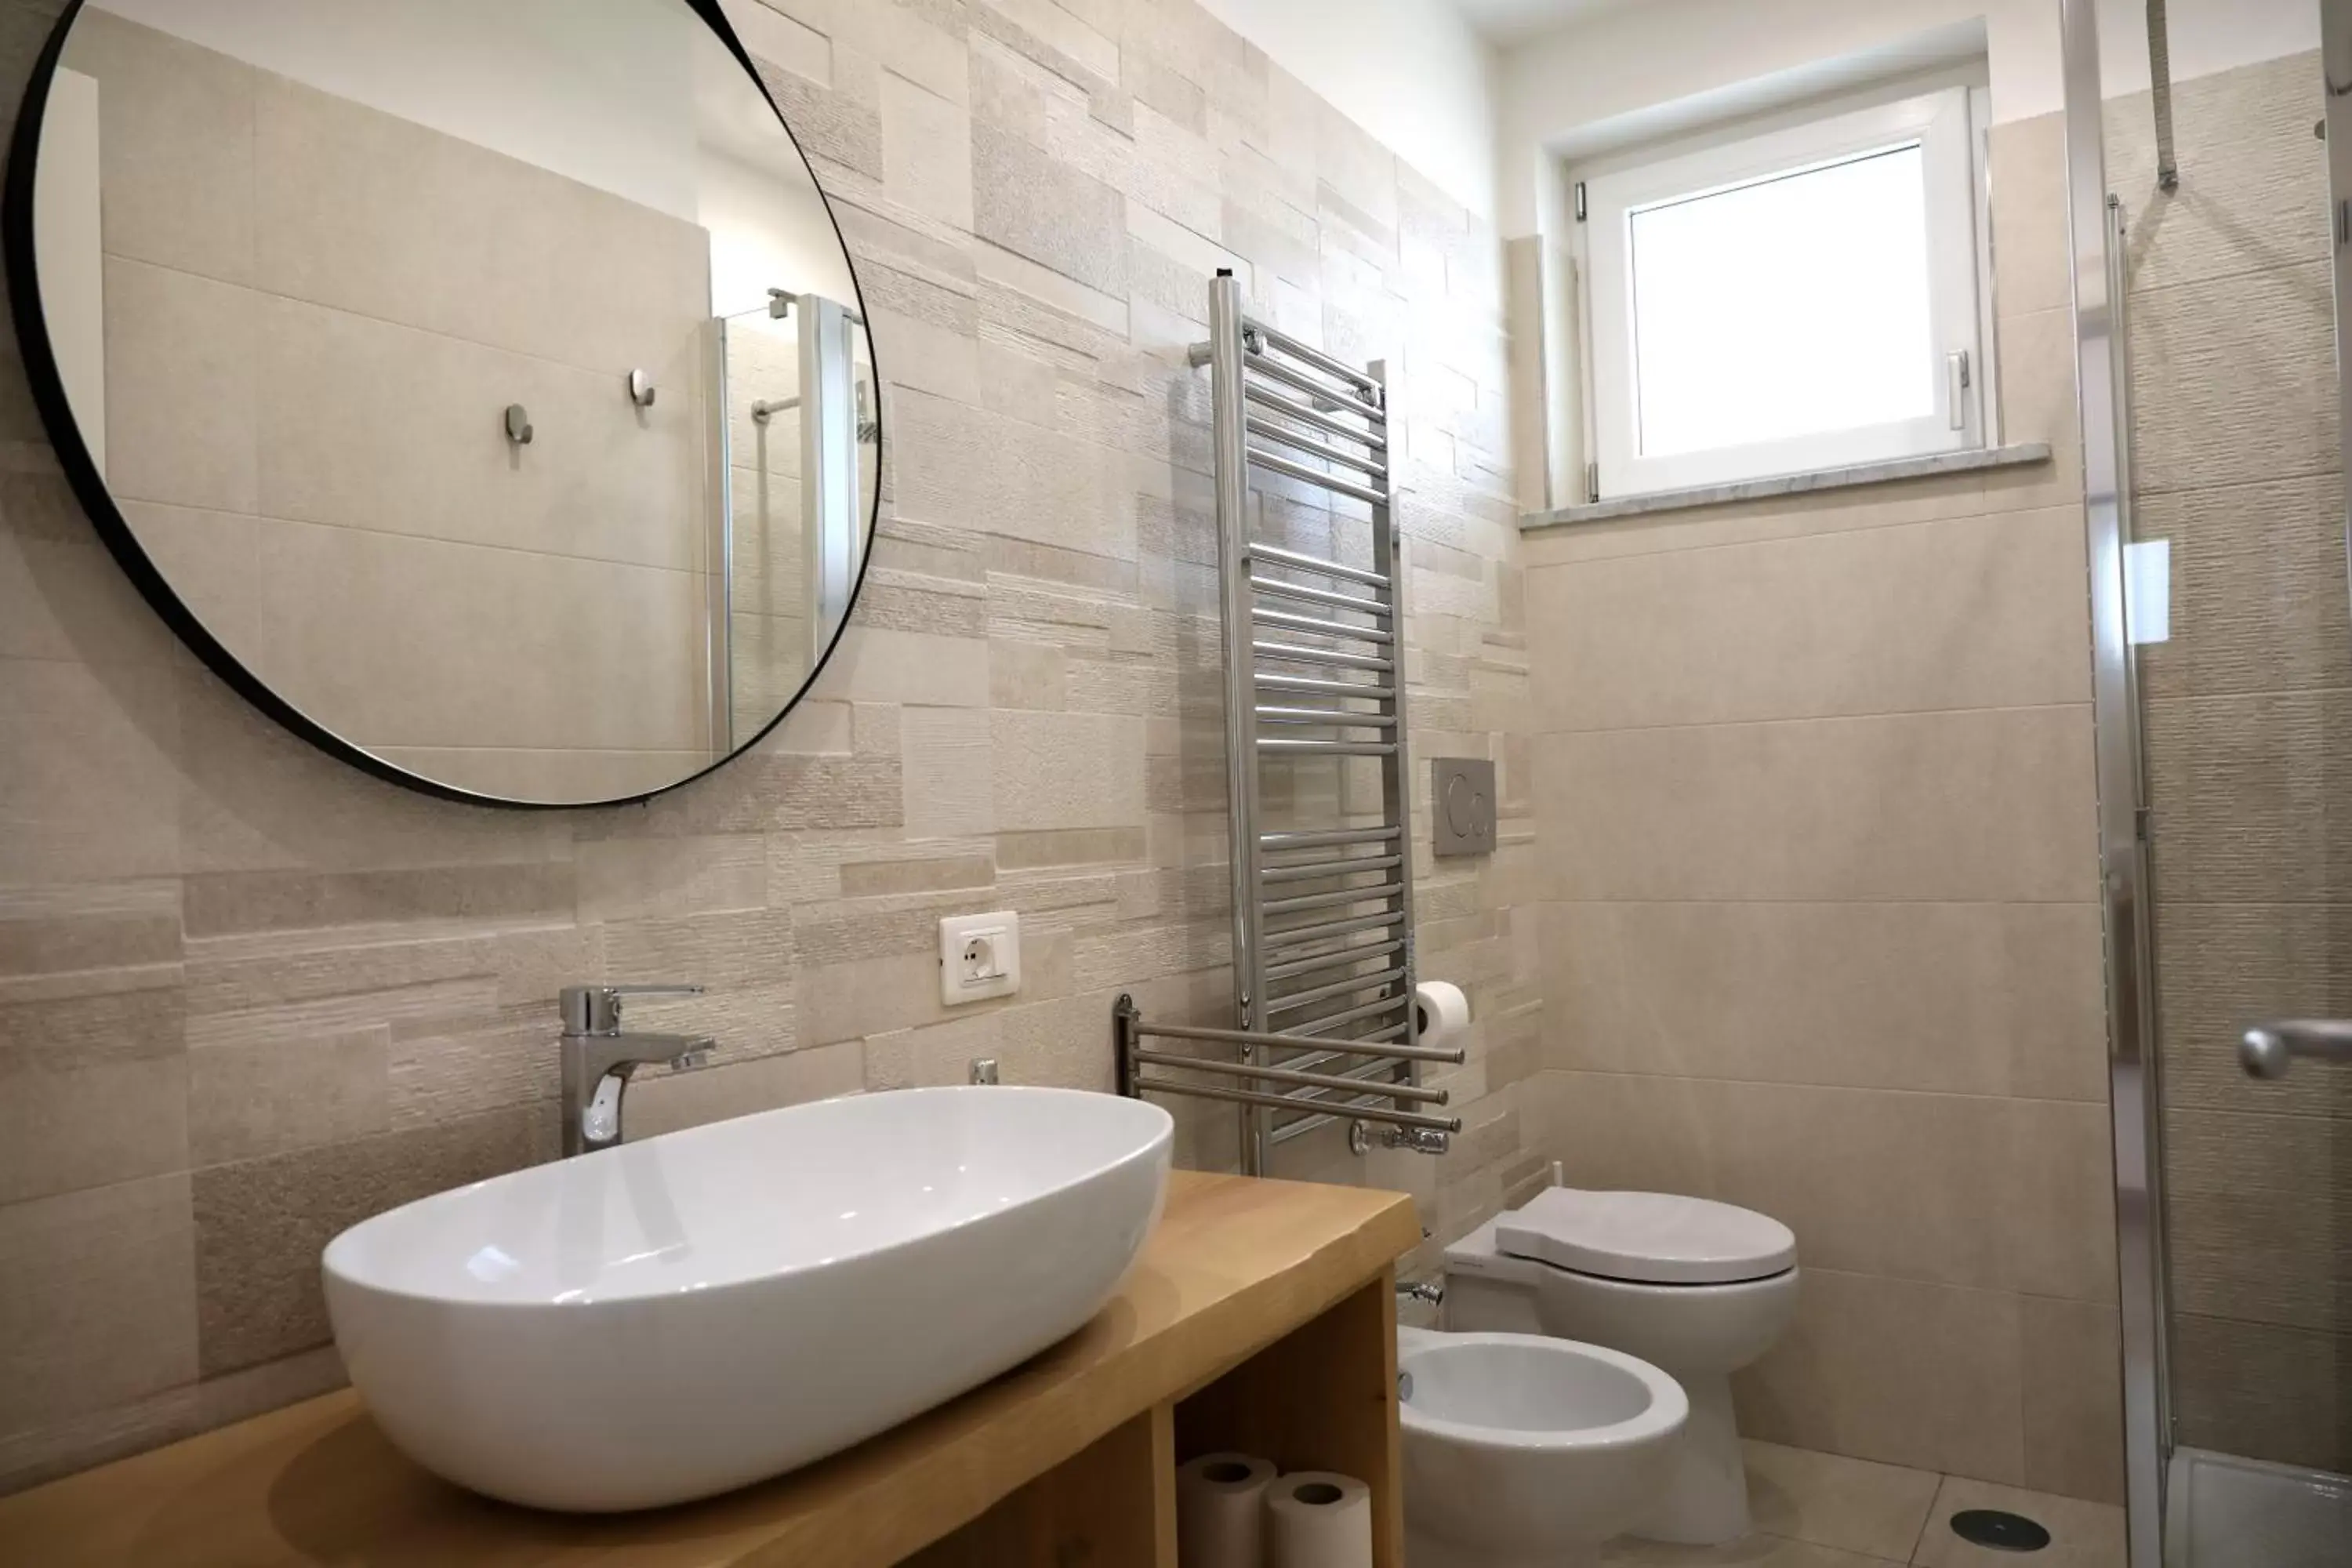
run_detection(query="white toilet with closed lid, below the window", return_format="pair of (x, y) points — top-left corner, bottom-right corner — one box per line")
(1446, 1187), (1797, 1547)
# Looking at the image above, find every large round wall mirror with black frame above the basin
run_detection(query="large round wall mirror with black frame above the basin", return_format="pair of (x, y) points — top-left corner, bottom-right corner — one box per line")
(7, 0), (882, 806)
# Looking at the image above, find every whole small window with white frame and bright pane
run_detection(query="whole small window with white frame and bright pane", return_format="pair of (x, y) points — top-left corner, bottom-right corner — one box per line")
(1583, 87), (1985, 496)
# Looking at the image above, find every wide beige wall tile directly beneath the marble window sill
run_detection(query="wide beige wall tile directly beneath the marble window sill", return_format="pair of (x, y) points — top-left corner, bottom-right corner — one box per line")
(1526, 508), (2091, 729)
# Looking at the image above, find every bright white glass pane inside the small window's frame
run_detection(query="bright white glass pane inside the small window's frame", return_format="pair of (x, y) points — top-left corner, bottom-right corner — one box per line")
(1628, 146), (1936, 456)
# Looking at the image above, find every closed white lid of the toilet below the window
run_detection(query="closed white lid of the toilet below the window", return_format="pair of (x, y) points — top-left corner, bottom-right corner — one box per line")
(1494, 1187), (1797, 1286)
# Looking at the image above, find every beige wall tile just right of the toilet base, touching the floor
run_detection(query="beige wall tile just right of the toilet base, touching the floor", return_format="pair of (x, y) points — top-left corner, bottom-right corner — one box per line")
(1733, 1269), (2025, 1483)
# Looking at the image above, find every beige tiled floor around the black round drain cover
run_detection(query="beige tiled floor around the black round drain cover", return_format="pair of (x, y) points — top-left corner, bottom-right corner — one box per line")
(1602, 1443), (2124, 1568)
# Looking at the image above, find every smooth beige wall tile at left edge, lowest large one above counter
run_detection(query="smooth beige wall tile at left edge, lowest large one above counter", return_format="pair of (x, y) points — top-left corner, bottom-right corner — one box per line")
(0, 1175), (198, 1432)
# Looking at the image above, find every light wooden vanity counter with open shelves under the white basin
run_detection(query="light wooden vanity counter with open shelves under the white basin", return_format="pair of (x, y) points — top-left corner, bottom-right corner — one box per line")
(0, 1171), (1421, 1568)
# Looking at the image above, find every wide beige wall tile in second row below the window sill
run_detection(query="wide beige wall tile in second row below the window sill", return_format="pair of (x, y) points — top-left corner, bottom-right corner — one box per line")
(1536, 708), (2098, 902)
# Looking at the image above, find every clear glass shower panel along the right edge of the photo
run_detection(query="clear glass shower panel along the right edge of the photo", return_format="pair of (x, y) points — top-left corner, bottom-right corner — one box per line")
(2065, 0), (2352, 1568)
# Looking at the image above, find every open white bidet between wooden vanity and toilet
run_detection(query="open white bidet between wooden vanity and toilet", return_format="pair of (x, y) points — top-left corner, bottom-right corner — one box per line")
(1397, 1328), (1689, 1568)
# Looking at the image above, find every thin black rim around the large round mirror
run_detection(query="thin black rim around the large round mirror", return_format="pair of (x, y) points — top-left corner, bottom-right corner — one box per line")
(0, 0), (889, 811)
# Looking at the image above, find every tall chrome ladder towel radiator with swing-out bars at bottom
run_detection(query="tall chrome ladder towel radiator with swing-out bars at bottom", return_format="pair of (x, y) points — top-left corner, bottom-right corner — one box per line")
(1112, 273), (1463, 1175)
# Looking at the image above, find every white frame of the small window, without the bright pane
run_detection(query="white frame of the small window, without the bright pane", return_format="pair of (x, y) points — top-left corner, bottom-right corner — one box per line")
(1581, 87), (1987, 499)
